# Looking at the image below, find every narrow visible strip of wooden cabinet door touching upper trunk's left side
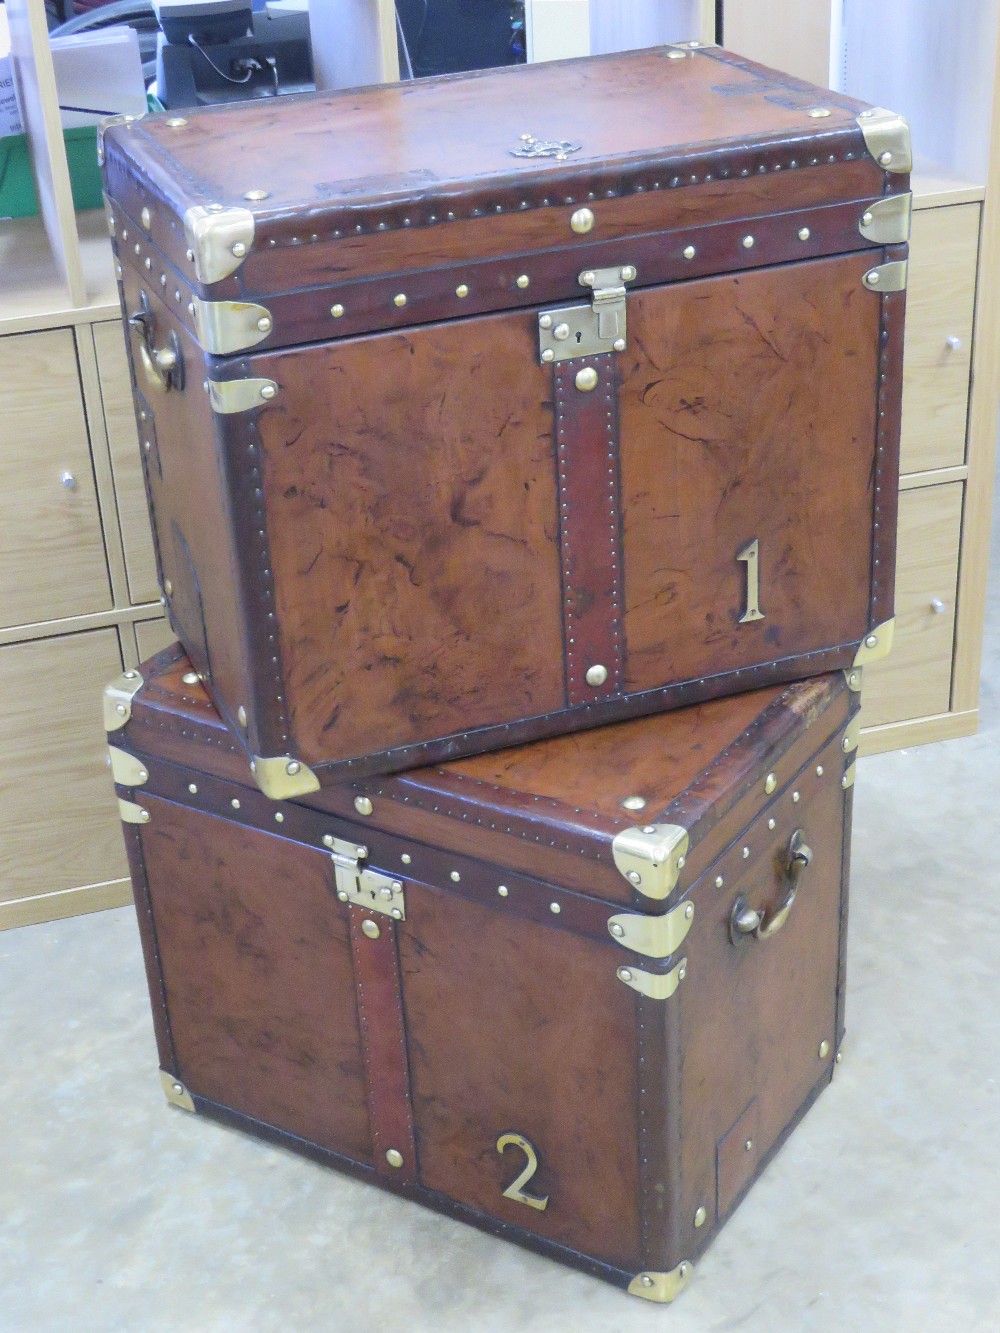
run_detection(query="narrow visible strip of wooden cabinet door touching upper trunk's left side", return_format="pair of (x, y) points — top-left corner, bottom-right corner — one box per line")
(93, 320), (160, 603)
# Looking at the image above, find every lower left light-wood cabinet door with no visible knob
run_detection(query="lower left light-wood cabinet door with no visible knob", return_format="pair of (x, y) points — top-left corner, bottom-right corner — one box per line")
(0, 629), (128, 902)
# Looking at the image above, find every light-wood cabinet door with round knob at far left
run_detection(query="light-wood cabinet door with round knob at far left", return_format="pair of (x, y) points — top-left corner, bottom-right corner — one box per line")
(0, 329), (111, 625)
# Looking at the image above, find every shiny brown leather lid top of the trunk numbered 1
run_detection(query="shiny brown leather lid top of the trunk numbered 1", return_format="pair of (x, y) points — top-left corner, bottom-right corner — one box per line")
(105, 48), (877, 297)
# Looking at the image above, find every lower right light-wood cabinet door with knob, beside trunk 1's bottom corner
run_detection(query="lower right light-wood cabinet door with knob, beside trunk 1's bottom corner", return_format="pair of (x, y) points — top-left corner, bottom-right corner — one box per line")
(863, 481), (963, 726)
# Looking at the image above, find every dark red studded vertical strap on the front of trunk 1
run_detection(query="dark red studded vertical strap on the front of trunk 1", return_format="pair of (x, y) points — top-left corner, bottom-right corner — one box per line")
(552, 352), (624, 704)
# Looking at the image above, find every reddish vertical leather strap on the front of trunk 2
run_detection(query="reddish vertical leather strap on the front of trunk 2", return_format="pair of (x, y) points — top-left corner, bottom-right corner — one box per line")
(349, 904), (417, 1185)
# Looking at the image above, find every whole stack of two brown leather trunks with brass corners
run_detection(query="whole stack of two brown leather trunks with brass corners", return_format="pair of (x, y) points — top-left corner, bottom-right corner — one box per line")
(104, 47), (909, 1300)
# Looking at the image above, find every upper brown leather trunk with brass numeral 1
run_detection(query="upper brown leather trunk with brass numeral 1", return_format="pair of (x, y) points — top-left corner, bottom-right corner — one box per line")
(103, 47), (909, 797)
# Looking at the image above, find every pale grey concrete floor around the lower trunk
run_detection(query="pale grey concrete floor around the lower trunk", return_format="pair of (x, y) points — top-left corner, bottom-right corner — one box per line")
(0, 511), (1000, 1333)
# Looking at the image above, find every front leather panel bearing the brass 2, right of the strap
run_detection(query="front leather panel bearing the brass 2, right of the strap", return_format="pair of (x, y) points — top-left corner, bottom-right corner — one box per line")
(399, 890), (639, 1269)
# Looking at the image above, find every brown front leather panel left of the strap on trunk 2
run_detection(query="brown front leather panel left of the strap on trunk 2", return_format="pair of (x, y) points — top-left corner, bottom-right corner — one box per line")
(136, 793), (372, 1161)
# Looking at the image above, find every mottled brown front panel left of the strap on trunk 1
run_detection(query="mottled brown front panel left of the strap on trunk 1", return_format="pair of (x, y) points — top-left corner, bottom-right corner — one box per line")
(252, 302), (564, 765)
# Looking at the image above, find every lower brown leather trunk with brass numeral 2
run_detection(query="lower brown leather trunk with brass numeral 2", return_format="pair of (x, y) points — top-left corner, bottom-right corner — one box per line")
(107, 649), (859, 1300)
